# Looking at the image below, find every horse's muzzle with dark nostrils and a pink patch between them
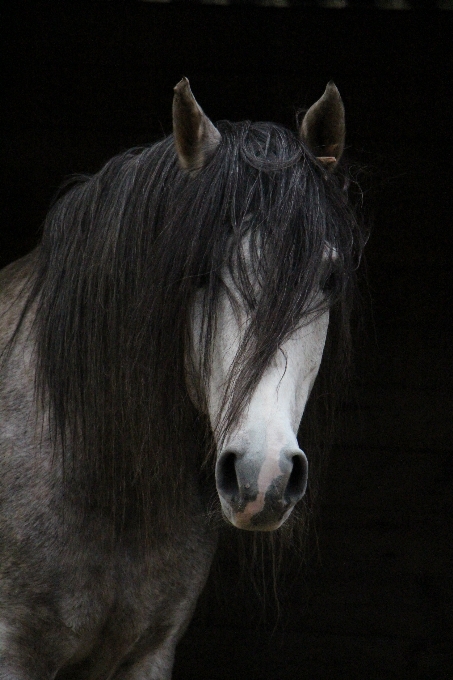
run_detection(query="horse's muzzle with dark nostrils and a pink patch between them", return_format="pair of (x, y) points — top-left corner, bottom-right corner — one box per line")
(216, 447), (308, 531)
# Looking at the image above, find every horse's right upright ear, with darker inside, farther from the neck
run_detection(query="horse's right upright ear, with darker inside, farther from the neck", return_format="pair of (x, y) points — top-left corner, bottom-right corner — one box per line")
(299, 81), (346, 170)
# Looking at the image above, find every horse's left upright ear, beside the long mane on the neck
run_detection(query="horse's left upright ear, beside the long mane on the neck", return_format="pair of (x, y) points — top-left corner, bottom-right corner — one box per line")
(173, 78), (221, 174)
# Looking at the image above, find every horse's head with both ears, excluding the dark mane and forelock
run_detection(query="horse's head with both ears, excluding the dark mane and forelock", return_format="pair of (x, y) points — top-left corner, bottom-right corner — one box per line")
(173, 79), (345, 531)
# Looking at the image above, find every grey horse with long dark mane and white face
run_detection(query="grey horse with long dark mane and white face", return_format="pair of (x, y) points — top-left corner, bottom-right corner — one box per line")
(0, 79), (361, 680)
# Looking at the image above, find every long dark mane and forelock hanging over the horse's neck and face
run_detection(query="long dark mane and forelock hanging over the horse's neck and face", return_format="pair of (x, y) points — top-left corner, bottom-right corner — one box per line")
(20, 121), (362, 536)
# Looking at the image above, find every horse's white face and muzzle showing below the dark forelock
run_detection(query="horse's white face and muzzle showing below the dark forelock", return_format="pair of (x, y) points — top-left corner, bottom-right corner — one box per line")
(190, 255), (329, 531)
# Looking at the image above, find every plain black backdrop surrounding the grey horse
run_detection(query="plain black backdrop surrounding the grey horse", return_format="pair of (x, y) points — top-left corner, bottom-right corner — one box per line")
(0, 3), (453, 680)
